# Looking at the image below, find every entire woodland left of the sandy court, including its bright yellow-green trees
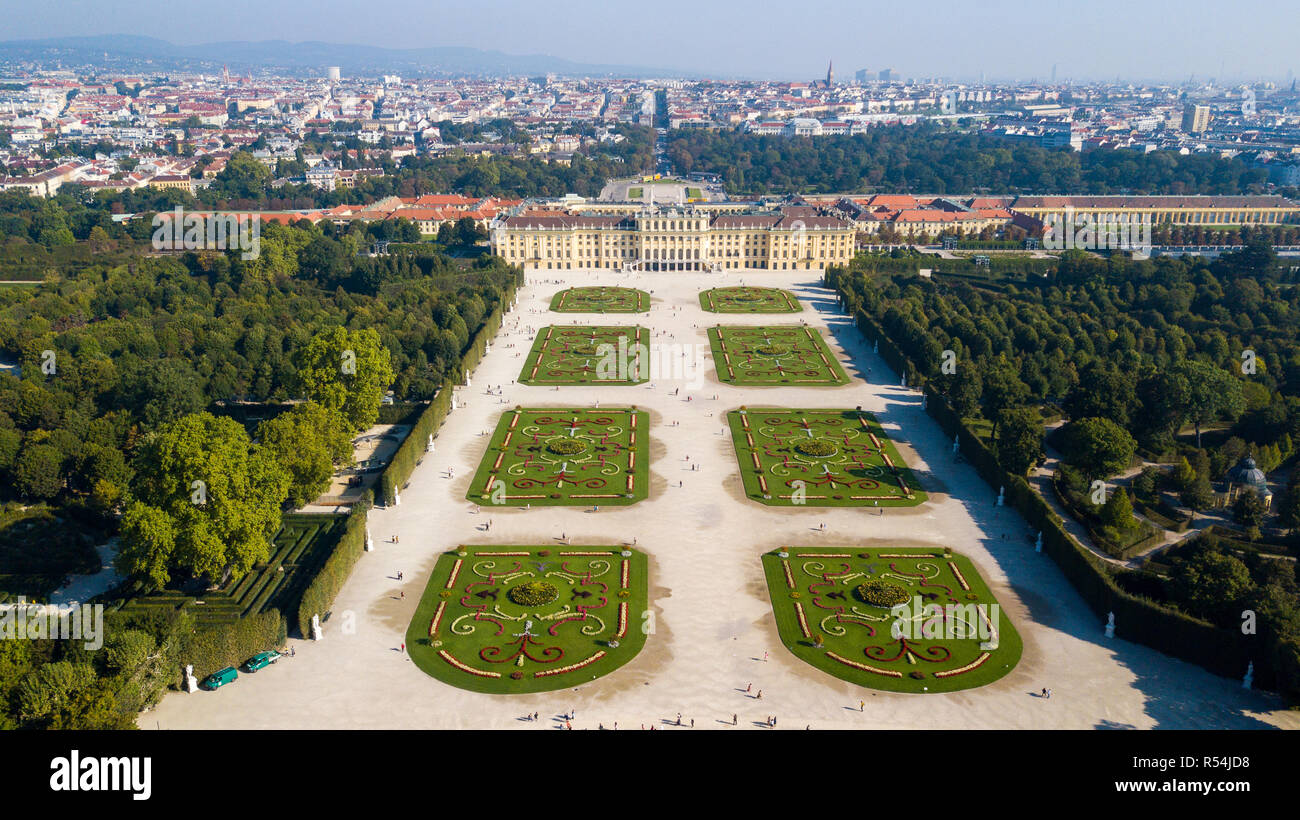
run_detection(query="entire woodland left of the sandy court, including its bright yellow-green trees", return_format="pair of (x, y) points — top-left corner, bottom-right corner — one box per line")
(0, 207), (517, 728)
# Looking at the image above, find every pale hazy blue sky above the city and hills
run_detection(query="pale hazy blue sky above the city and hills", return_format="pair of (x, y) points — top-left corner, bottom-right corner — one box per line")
(0, 0), (1300, 81)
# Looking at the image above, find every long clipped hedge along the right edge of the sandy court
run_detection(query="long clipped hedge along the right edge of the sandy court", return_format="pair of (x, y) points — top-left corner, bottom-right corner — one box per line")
(827, 269), (1275, 687)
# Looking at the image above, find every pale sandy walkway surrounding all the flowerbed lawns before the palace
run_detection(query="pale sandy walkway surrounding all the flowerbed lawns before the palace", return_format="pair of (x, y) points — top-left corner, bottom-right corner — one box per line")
(139, 272), (1300, 729)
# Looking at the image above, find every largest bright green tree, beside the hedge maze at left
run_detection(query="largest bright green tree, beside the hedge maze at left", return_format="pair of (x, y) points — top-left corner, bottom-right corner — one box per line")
(117, 413), (290, 585)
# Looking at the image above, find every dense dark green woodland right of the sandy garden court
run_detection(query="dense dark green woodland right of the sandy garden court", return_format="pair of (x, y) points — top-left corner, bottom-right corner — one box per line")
(835, 240), (1300, 697)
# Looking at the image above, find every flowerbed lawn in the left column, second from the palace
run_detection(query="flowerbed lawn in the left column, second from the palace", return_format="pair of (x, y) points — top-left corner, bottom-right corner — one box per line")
(519, 325), (650, 385)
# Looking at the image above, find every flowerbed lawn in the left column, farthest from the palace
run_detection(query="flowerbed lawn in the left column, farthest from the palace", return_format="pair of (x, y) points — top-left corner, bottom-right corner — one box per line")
(406, 546), (650, 694)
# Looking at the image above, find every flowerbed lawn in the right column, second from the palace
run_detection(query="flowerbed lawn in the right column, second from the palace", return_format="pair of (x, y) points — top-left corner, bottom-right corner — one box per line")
(709, 325), (849, 386)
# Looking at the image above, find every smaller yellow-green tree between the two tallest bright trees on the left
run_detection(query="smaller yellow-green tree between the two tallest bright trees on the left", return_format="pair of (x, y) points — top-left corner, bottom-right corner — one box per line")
(257, 402), (352, 507)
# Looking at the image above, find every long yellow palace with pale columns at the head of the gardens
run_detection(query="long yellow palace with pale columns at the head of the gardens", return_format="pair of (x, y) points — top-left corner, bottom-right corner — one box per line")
(491, 207), (854, 270)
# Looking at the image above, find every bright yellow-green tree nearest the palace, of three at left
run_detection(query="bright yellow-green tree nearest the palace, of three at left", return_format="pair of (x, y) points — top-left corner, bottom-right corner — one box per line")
(295, 326), (393, 430)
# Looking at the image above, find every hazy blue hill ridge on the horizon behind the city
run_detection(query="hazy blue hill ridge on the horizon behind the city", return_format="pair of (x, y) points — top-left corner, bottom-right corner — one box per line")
(0, 34), (685, 77)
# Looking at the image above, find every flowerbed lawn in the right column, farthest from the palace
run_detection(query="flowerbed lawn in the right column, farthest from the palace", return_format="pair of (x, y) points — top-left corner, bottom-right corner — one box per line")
(763, 547), (1022, 694)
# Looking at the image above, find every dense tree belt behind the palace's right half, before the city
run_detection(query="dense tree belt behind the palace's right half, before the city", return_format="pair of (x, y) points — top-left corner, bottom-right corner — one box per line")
(667, 123), (1268, 194)
